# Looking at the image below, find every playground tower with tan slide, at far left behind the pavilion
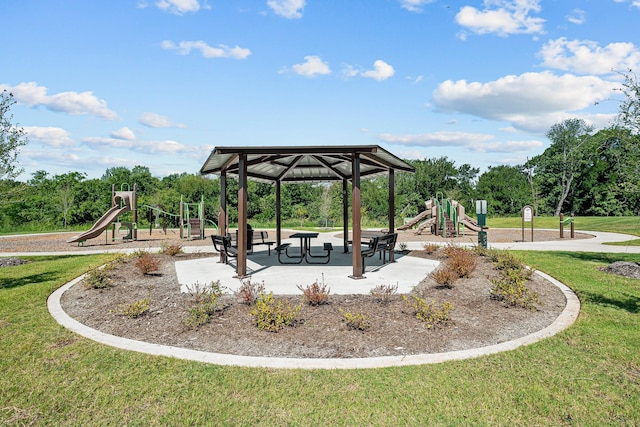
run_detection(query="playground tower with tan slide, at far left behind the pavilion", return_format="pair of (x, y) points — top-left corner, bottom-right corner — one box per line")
(67, 184), (138, 245)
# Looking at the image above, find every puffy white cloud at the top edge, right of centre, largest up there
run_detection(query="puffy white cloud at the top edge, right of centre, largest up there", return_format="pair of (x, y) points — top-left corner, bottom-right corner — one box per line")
(456, 0), (545, 36)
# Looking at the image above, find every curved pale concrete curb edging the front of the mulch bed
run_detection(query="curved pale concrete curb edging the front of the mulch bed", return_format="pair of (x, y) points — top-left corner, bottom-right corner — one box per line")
(47, 271), (580, 369)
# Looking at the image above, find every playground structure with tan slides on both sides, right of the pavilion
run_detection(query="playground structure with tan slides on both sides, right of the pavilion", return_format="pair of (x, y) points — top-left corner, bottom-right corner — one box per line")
(397, 193), (484, 238)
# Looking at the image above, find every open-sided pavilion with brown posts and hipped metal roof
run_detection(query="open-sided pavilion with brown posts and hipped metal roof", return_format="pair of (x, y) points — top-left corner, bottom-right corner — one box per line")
(200, 145), (415, 279)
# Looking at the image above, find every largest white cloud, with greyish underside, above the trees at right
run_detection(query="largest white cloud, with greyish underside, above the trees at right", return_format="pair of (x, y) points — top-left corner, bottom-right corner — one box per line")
(433, 71), (616, 132)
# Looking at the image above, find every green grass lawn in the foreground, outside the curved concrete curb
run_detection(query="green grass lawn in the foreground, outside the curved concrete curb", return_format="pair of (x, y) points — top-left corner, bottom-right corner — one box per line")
(0, 252), (640, 426)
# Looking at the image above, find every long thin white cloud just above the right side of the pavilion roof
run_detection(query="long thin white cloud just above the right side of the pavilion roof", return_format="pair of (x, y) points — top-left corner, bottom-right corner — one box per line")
(377, 131), (544, 153)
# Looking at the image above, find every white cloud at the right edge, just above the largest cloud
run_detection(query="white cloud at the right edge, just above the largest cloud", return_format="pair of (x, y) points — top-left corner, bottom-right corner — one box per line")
(538, 37), (640, 74)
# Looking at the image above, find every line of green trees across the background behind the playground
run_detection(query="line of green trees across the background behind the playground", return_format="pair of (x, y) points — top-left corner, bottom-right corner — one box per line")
(0, 70), (640, 232)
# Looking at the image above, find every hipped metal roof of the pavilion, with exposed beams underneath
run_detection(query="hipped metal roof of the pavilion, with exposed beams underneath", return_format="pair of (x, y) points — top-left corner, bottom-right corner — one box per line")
(200, 145), (415, 183)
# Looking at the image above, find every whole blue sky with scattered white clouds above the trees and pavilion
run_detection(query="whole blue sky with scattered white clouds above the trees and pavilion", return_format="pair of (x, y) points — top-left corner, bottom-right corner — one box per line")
(0, 0), (640, 179)
